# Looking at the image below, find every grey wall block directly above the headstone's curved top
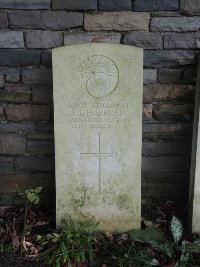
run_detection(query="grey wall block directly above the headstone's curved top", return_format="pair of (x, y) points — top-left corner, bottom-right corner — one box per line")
(64, 32), (121, 45)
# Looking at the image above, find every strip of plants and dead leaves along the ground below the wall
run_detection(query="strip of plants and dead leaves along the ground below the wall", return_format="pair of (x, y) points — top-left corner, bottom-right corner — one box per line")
(0, 194), (200, 267)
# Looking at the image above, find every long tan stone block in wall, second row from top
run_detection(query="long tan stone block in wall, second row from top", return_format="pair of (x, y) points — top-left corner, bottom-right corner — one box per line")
(84, 12), (150, 31)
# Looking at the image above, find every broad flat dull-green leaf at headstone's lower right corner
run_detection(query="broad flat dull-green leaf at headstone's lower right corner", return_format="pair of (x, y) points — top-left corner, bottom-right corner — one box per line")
(129, 226), (165, 243)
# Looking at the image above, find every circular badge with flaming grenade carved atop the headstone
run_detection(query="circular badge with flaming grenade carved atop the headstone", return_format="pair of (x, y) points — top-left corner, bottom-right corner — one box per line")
(79, 55), (119, 98)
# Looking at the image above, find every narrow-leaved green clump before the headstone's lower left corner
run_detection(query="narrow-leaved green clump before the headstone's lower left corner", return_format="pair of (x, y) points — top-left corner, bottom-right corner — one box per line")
(37, 218), (99, 267)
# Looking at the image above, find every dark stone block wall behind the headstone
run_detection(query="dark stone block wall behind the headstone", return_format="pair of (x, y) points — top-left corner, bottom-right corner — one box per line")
(0, 0), (200, 204)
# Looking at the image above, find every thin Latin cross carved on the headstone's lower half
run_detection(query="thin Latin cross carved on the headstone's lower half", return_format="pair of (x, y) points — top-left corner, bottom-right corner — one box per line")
(80, 133), (117, 193)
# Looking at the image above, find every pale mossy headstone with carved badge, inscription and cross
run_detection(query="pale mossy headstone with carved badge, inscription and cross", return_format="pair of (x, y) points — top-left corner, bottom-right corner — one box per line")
(53, 44), (143, 232)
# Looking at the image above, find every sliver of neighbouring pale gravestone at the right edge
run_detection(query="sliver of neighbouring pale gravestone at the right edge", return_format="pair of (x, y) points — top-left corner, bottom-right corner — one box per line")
(189, 55), (200, 232)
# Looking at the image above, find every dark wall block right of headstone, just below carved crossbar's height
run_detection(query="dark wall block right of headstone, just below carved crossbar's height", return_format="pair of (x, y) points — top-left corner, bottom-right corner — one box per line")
(142, 156), (190, 172)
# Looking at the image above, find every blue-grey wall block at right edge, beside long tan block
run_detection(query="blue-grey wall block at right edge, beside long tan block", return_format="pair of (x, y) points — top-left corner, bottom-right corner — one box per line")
(150, 17), (200, 32)
